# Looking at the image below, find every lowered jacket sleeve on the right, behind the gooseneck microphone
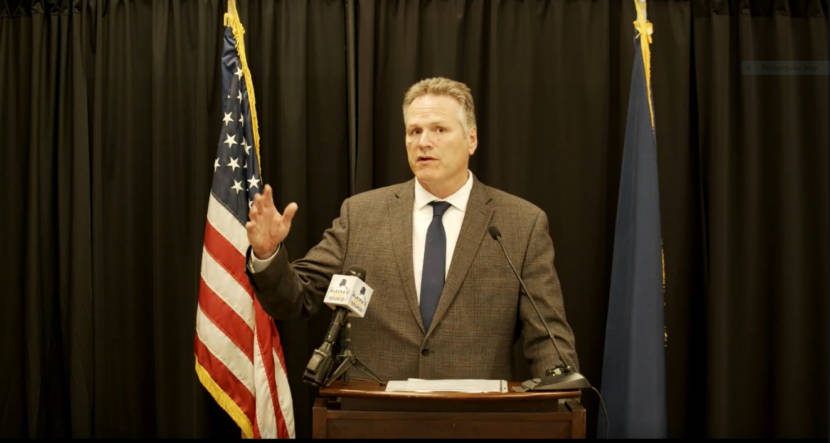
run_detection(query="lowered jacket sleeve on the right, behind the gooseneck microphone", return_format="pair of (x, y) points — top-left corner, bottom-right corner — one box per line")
(519, 210), (579, 376)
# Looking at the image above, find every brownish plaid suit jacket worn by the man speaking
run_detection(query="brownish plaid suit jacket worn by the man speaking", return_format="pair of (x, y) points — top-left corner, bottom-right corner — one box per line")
(249, 179), (579, 380)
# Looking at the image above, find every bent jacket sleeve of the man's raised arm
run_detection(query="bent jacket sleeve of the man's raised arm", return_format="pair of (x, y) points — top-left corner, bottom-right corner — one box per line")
(246, 199), (349, 320)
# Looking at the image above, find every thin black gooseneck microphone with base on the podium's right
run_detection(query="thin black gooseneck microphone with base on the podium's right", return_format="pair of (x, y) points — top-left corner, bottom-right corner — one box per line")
(487, 225), (593, 391)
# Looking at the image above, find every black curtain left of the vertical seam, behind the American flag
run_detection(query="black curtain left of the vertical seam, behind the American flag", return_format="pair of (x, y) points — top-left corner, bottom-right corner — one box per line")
(0, 0), (349, 437)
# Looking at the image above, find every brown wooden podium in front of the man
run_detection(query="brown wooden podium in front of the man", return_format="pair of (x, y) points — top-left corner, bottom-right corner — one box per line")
(312, 380), (585, 438)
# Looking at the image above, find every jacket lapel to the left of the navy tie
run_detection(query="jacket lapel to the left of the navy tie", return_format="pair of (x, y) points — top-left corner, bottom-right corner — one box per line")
(389, 179), (424, 331)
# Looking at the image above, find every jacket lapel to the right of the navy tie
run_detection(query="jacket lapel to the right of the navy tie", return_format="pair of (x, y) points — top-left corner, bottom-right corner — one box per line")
(428, 178), (493, 331)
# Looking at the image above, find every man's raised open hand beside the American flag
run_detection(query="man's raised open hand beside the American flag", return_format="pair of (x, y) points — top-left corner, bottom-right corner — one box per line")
(245, 185), (298, 259)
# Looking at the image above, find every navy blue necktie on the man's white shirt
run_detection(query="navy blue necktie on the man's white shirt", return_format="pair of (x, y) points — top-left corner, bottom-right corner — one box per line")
(421, 201), (450, 331)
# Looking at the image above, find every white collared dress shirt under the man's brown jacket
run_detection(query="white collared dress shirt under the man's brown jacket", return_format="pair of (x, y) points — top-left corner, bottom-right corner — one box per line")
(412, 170), (473, 303)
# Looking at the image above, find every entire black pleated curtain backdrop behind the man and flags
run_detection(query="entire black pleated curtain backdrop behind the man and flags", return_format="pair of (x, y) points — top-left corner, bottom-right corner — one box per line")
(0, 0), (830, 438)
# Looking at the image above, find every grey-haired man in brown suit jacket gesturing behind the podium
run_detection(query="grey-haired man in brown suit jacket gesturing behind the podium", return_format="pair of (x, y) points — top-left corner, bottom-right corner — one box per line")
(246, 78), (578, 380)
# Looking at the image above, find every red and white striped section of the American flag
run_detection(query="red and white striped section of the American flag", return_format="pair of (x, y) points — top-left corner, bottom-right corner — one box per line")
(194, 194), (295, 438)
